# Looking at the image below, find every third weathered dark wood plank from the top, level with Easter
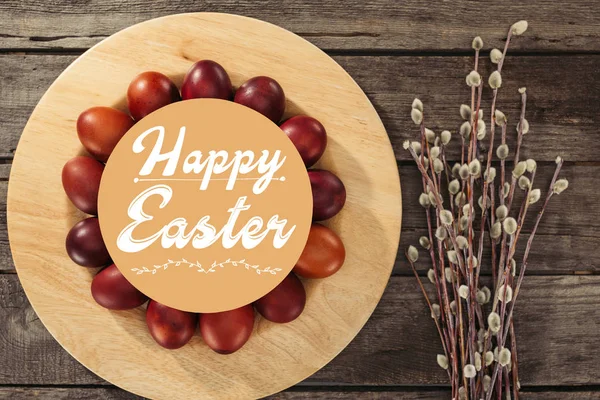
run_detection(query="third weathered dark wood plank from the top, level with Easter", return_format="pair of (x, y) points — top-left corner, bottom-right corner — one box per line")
(0, 164), (600, 274)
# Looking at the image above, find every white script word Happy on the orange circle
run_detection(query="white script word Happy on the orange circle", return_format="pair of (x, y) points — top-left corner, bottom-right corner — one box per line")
(132, 126), (286, 194)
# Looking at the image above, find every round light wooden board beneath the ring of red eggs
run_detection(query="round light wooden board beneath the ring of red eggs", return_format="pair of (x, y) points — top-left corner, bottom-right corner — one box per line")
(8, 13), (401, 399)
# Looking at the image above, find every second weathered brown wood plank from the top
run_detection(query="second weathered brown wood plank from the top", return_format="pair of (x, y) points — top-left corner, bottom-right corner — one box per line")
(0, 54), (600, 162)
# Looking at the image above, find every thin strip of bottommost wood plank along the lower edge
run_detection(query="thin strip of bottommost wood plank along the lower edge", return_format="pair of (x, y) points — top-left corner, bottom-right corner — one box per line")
(0, 387), (600, 400)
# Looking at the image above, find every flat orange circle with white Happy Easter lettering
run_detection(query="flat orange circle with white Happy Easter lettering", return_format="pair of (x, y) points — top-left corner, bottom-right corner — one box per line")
(98, 99), (312, 312)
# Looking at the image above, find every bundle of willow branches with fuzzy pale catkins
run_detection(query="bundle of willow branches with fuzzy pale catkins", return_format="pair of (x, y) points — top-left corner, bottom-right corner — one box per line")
(404, 21), (568, 400)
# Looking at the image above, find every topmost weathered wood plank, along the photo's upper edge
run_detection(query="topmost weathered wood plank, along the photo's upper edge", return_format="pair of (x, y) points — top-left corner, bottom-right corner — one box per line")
(0, 0), (600, 51)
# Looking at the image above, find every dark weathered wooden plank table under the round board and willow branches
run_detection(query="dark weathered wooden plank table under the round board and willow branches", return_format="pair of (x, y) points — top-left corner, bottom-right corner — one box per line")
(0, 0), (600, 399)
